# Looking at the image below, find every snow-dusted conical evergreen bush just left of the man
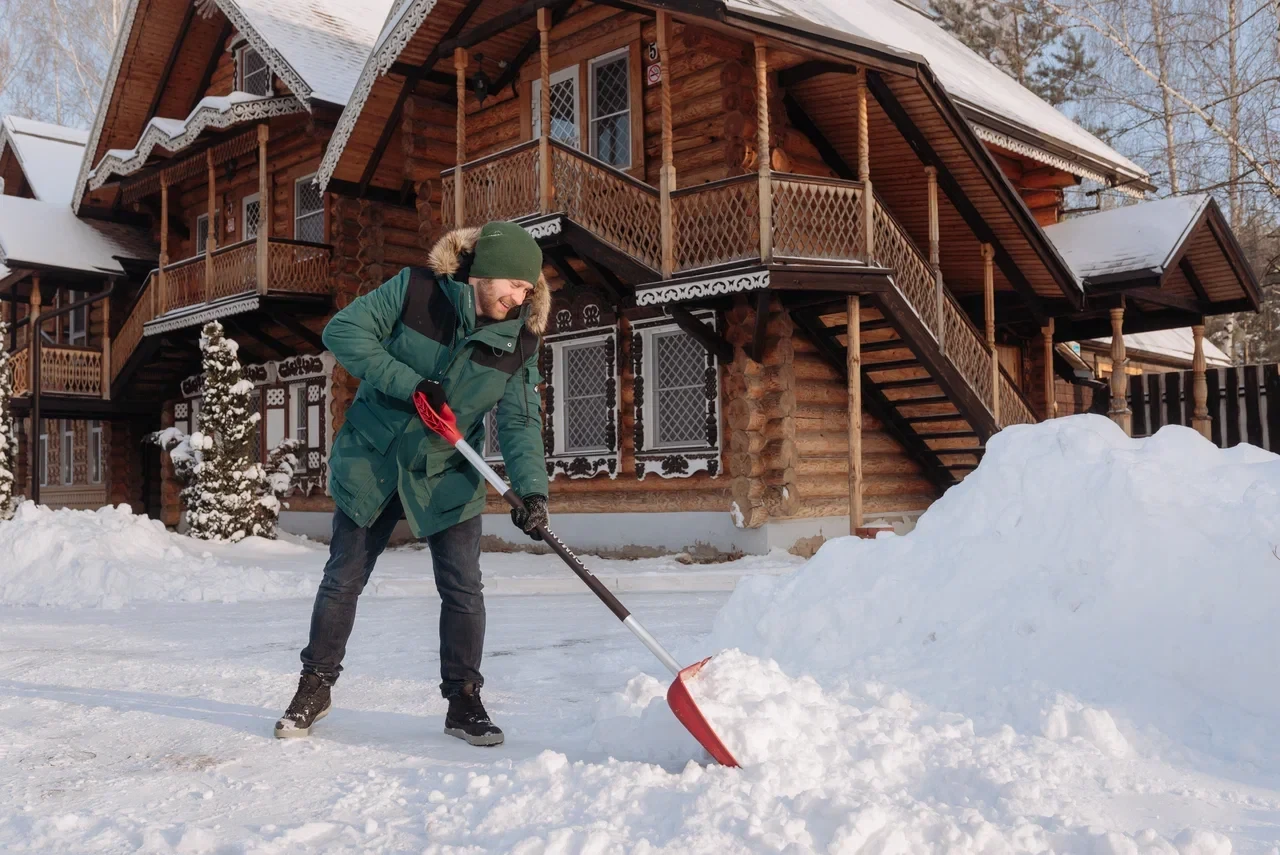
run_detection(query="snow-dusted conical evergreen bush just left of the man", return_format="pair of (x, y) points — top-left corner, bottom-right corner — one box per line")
(150, 321), (297, 541)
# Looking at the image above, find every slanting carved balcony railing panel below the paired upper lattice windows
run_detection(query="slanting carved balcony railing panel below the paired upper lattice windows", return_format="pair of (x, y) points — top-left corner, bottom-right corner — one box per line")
(552, 141), (662, 270)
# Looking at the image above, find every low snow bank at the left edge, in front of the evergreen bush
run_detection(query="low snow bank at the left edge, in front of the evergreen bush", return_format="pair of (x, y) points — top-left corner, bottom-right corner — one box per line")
(0, 502), (319, 608)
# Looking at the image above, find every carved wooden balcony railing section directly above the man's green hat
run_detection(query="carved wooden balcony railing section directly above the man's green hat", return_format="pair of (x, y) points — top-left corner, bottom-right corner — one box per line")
(440, 140), (539, 228)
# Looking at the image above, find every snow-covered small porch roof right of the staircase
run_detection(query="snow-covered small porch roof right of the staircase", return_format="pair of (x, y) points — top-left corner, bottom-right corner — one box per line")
(1044, 193), (1211, 279)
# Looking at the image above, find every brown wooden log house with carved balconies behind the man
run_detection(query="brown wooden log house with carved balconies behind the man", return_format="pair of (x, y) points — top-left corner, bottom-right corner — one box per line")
(7, 0), (1258, 552)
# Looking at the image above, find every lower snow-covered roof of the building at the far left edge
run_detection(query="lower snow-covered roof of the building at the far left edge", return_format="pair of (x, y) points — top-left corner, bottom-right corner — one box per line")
(0, 196), (159, 274)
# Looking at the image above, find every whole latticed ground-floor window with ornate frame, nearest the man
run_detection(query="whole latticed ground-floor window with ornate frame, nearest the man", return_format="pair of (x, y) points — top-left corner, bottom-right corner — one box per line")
(541, 325), (620, 479)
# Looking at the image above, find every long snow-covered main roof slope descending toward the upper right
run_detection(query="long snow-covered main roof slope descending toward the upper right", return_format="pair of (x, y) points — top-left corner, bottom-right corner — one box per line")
(724, 0), (1148, 182)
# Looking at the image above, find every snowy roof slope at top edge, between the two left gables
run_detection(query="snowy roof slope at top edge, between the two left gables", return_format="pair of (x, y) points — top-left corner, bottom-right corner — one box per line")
(218, 0), (393, 106)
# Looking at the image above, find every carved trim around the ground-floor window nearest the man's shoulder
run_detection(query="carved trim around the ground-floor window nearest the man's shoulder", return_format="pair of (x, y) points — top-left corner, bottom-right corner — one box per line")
(539, 325), (622, 480)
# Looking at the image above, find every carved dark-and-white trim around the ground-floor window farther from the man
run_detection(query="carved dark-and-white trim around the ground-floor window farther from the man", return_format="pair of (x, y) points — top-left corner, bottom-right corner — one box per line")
(631, 310), (721, 481)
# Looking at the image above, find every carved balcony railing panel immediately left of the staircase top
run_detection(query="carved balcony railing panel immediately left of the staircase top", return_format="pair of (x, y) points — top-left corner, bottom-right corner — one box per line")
(772, 173), (867, 261)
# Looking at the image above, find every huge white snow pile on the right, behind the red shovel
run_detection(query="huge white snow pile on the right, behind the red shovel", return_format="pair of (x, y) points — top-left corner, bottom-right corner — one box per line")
(712, 416), (1280, 768)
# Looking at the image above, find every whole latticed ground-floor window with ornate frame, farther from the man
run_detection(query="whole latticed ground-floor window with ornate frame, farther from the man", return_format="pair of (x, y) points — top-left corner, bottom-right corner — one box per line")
(631, 311), (721, 480)
